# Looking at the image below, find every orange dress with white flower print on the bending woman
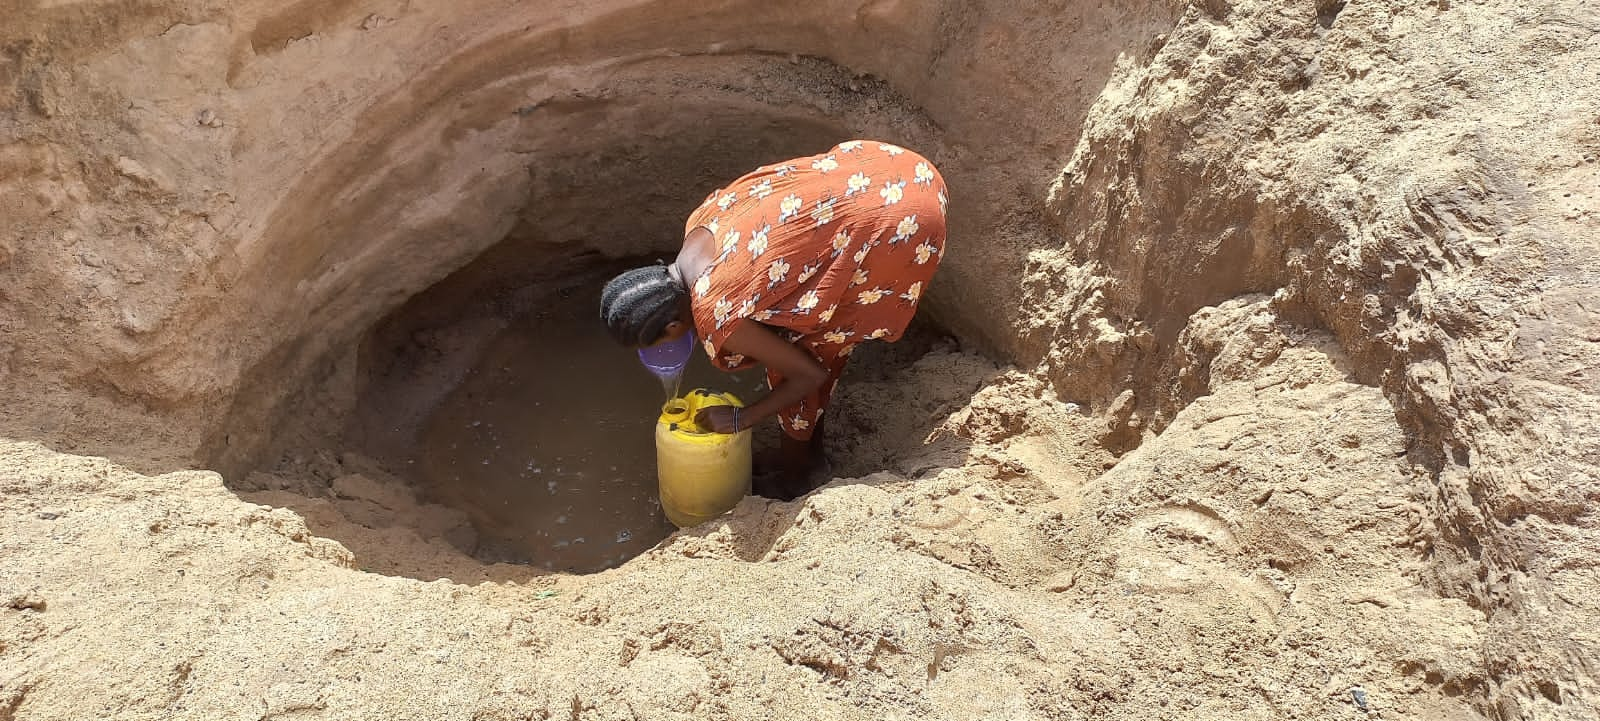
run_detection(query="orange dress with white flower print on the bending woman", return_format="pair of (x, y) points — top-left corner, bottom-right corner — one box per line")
(685, 141), (949, 440)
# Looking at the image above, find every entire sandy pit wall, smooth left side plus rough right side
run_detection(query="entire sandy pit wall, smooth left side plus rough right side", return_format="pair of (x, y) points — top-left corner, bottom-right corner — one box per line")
(0, 0), (1600, 718)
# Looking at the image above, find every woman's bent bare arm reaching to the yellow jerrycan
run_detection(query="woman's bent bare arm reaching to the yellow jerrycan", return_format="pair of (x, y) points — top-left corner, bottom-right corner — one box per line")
(694, 318), (827, 433)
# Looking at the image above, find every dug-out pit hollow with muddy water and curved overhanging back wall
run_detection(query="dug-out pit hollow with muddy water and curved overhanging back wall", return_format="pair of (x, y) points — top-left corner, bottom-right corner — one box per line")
(184, 29), (1062, 574)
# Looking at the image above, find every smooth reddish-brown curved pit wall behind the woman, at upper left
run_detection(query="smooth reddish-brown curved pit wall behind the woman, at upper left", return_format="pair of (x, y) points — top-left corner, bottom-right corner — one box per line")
(3, 2), (1171, 468)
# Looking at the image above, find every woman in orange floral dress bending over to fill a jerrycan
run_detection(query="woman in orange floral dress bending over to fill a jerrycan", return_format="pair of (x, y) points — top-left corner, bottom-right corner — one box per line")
(600, 141), (947, 497)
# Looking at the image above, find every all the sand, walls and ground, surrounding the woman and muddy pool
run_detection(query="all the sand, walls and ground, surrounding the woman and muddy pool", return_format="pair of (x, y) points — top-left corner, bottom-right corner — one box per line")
(0, 0), (1600, 721)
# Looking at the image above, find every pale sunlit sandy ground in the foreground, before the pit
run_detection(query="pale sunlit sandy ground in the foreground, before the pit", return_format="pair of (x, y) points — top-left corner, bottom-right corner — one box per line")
(3, 342), (1483, 719)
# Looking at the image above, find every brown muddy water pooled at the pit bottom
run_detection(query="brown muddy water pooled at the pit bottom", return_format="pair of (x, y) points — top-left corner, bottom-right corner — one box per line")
(408, 302), (765, 572)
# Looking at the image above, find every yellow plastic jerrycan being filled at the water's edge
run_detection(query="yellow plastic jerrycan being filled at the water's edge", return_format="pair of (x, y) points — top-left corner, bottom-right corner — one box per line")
(656, 388), (750, 528)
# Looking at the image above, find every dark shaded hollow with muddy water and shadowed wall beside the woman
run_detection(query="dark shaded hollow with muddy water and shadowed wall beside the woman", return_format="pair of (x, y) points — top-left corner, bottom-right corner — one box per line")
(230, 104), (972, 572)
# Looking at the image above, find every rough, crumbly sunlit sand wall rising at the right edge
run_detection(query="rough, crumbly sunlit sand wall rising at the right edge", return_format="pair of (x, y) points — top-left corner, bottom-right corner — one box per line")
(1024, 2), (1600, 718)
